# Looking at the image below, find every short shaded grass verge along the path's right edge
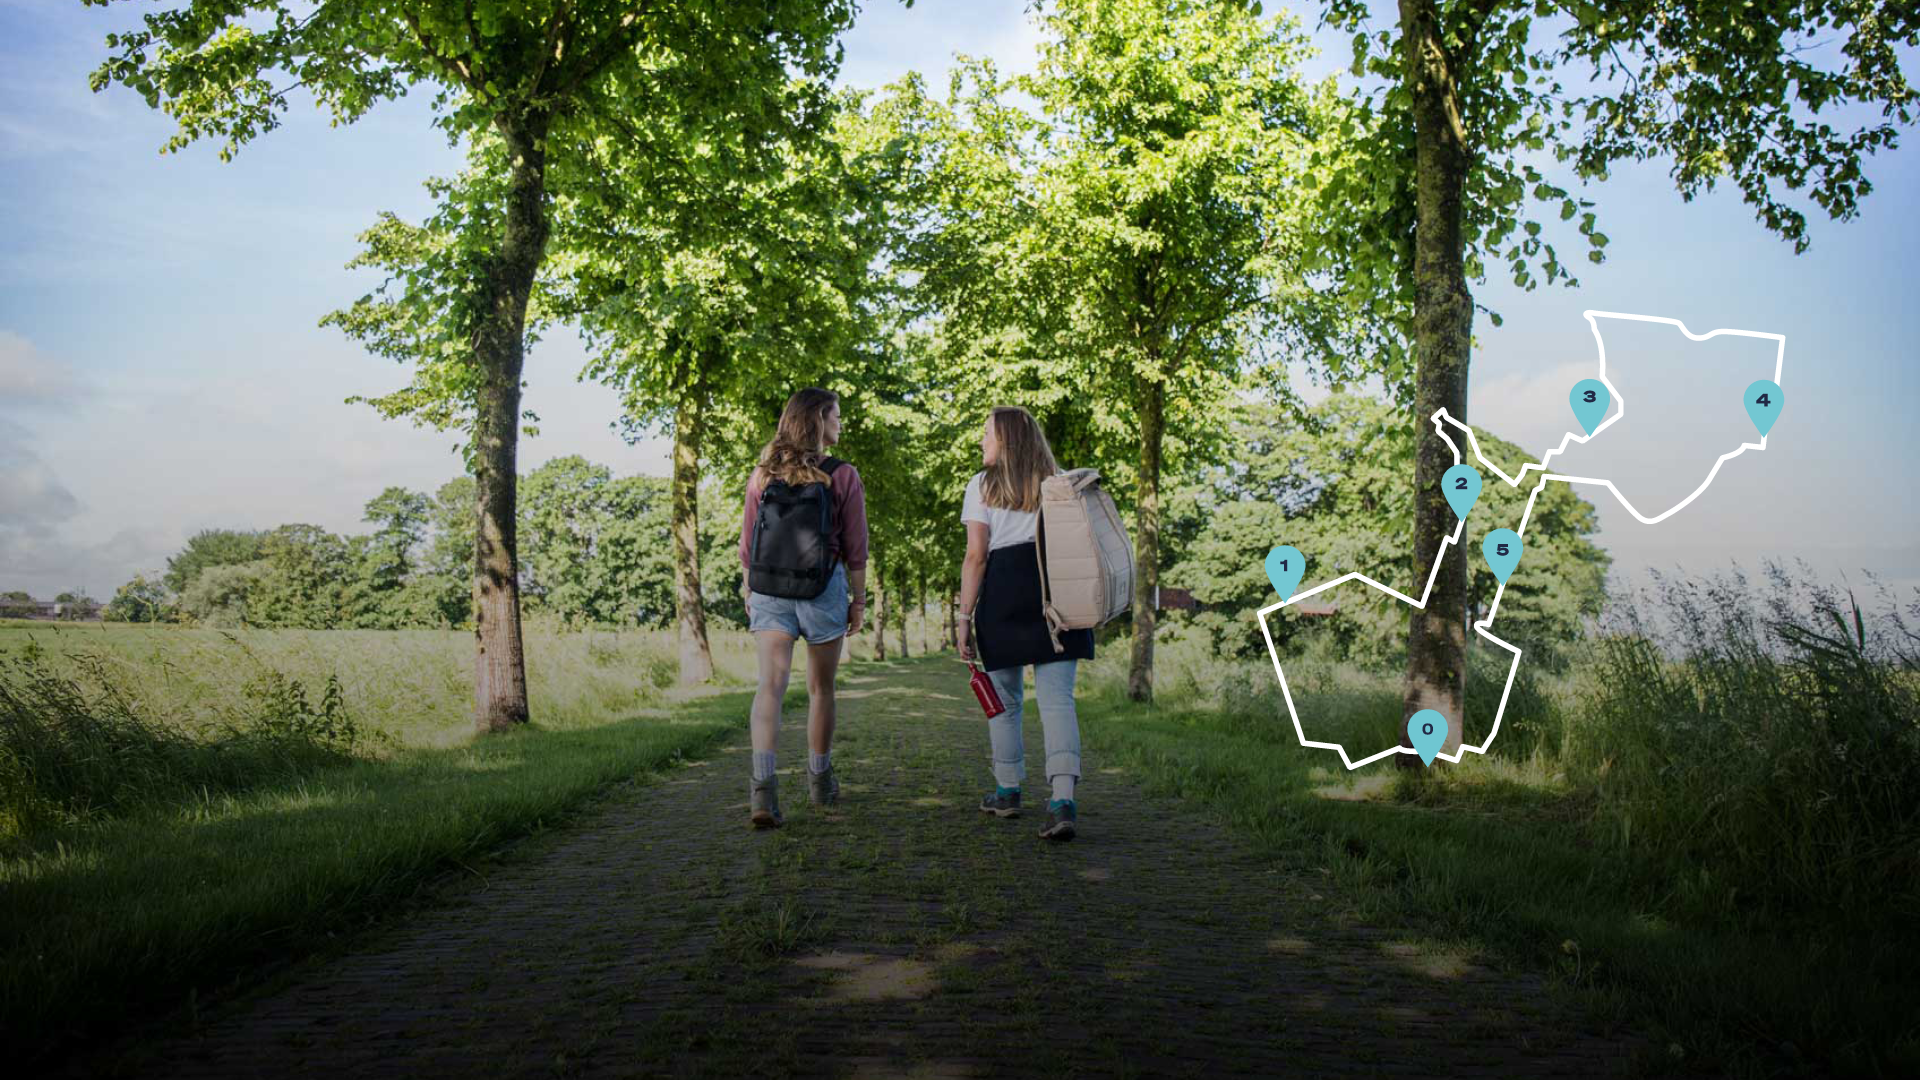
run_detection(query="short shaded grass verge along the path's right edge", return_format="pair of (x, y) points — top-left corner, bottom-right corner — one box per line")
(1083, 676), (1920, 1076)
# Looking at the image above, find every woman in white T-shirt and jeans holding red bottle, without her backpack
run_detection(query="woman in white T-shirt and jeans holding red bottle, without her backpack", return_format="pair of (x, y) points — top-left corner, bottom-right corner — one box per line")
(958, 405), (1092, 840)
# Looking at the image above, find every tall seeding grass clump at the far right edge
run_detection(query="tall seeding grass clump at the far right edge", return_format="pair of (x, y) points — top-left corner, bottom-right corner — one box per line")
(1569, 567), (1920, 920)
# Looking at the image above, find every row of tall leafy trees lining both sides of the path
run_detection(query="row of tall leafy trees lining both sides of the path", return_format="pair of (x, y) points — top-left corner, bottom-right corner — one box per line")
(94, 0), (1920, 728)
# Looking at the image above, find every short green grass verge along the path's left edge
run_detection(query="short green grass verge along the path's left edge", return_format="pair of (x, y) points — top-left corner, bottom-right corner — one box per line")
(0, 680), (747, 1061)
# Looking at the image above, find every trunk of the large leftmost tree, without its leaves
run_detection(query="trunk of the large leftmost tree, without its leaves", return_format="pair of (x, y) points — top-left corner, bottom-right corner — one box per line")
(472, 110), (547, 732)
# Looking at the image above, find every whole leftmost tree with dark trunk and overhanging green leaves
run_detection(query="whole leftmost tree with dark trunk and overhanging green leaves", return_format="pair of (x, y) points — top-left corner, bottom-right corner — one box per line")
(86, 0), (851, 730)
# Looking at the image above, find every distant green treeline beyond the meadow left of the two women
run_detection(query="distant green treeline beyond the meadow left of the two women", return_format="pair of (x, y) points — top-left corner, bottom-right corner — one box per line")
(106, 457), (745, 630)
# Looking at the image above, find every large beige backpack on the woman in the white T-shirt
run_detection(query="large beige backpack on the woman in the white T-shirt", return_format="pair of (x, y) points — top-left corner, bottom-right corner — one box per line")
(1039, 469), (1133, 653)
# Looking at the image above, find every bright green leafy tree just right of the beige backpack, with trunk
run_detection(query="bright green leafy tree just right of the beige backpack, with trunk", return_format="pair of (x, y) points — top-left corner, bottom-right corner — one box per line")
(893, 0), (1371, 700)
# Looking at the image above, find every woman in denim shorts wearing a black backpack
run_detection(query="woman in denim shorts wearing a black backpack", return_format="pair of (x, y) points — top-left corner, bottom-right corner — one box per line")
(739, 388), (866, 828)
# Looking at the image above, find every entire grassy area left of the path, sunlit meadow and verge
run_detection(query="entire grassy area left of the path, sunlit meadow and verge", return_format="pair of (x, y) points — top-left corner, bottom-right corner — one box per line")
(0, 625), (771, 1045)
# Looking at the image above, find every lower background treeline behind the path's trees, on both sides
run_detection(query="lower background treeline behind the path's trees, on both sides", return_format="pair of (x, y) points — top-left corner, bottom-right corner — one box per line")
(97, 394), (1607, 661)
